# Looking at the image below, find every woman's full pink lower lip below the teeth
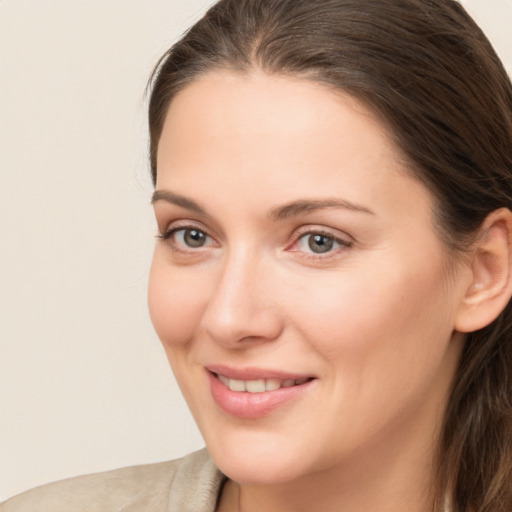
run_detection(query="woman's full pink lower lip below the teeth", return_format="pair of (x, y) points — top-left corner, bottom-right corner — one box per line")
(207, 371), (316, 420)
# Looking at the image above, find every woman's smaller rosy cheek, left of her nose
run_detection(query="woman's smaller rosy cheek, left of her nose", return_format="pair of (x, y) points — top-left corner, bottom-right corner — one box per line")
(148, 253), (208, 349)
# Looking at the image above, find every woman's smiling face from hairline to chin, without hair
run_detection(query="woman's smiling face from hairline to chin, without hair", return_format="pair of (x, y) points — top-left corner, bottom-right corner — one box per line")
(149, 71), (465, 483)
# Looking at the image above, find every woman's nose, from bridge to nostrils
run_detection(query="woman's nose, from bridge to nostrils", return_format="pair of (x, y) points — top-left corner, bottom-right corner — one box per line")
(202, 248), (283, 348)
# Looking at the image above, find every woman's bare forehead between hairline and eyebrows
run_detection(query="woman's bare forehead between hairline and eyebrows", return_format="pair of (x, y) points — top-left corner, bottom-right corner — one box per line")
(157, 71), (430, 230)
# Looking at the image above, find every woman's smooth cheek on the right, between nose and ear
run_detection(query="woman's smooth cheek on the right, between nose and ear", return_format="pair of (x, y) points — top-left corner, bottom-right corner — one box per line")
(290, 254), (453, 379)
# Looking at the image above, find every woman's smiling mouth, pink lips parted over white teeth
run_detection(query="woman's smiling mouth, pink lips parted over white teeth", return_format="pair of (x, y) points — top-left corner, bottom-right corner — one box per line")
(207, 368), (317, 419)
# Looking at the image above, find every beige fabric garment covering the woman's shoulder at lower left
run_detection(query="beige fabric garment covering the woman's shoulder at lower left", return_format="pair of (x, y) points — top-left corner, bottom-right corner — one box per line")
(0, 450), (224, 512)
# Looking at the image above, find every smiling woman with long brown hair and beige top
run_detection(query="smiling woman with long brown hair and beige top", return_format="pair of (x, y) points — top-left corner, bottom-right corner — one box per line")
(0, 0), (512, 512)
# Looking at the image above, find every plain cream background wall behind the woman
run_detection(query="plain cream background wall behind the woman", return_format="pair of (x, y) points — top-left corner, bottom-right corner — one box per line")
(0, 0), (512, 500)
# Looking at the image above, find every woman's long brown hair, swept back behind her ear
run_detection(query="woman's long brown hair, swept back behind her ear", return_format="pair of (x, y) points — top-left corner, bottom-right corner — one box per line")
(149, 0), (512, 512)
